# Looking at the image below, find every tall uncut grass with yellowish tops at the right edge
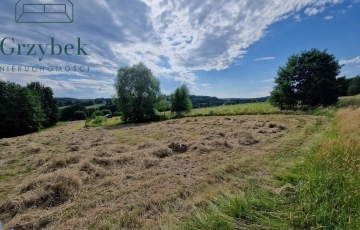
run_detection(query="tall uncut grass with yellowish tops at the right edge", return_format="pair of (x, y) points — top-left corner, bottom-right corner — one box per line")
(293, 109), (360, 229)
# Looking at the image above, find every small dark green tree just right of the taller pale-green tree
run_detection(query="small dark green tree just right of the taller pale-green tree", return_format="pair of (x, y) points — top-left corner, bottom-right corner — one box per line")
(170, 84), (192, 116)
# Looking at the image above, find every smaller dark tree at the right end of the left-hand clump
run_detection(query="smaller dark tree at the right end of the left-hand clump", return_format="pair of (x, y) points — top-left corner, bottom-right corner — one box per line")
(27, 82), (60, 128)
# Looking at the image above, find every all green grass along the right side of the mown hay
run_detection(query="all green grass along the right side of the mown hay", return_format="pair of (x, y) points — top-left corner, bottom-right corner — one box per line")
(177, 107), (360, 230)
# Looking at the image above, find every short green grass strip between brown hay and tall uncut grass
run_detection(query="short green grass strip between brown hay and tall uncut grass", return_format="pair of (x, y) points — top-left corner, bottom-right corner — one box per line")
(174, 113), (329, 230)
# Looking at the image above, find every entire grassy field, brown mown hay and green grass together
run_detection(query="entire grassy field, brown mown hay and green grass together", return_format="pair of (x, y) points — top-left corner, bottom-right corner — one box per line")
(0, 97), (360, 230)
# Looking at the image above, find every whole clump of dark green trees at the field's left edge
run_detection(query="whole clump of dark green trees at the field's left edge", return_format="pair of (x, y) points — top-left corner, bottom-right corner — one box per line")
(0, 80), (60, 138)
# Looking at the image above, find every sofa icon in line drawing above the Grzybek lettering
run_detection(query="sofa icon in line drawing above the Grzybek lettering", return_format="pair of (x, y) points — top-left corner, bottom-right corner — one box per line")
(15, 0), (74, 23)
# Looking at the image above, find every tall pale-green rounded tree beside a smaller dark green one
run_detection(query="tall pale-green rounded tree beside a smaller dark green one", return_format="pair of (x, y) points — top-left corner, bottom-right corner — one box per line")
(115, 63), (160, 122)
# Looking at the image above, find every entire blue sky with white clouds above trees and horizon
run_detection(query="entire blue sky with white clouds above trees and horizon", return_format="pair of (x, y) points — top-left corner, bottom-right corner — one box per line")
(0, 0), (360, 98)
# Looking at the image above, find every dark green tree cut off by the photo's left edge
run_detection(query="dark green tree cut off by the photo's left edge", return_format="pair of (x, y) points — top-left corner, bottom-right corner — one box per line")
(0, 80), (45, 138)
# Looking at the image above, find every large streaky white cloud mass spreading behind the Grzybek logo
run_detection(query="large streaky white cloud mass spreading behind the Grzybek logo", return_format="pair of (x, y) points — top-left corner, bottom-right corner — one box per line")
(0, 0), (348, 97)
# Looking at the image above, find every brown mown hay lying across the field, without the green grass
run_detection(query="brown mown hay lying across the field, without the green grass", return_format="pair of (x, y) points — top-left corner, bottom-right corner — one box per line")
(0, 115), (323, 230)
